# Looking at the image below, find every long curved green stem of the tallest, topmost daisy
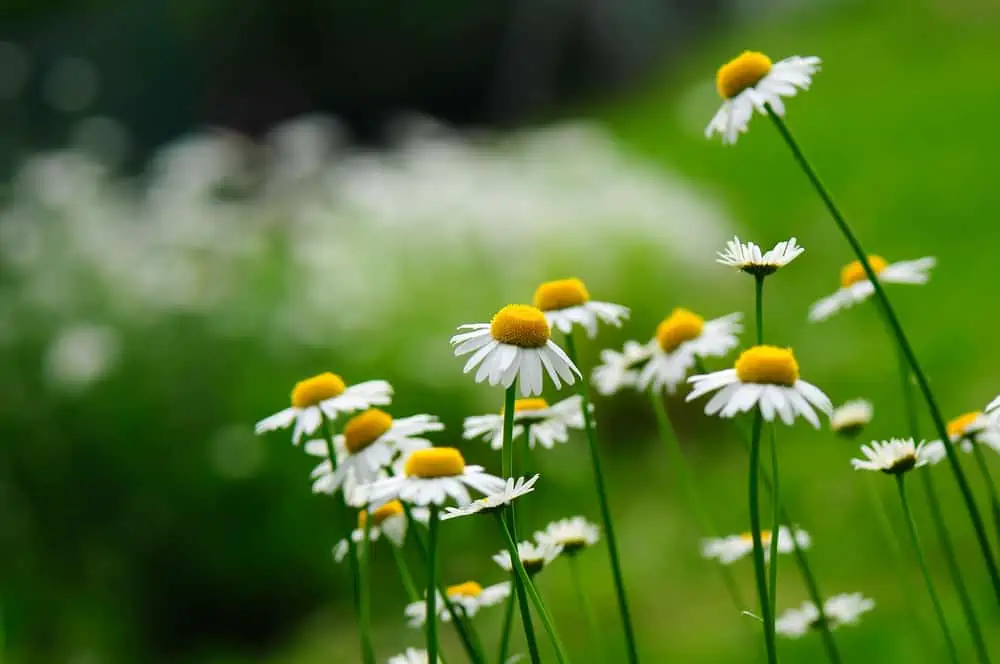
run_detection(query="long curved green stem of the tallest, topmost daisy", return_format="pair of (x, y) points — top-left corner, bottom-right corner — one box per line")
(765, 105), (1000, 603)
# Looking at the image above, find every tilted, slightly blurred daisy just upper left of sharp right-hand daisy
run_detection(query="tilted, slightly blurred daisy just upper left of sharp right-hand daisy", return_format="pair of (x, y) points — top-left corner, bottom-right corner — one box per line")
(636, 308), (743, 394)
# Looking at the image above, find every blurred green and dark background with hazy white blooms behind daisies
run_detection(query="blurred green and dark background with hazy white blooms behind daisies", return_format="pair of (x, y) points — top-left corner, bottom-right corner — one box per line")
(0, 0), (1000, 664)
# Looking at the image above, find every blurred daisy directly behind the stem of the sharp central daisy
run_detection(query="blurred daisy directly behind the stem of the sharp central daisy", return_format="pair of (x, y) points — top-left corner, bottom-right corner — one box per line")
(462, 395), (583, 450)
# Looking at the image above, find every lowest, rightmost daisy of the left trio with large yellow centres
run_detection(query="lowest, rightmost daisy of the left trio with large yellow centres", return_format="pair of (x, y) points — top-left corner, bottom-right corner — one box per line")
(358, 447), (506, 506)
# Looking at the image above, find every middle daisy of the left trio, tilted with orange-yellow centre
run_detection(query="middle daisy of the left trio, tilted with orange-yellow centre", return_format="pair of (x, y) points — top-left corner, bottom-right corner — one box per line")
(306, 408), (444, 493)
